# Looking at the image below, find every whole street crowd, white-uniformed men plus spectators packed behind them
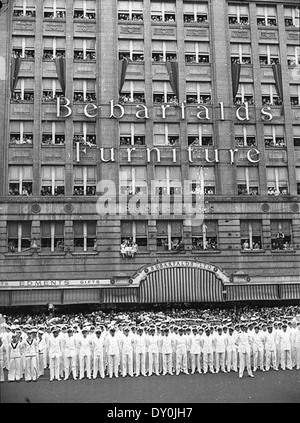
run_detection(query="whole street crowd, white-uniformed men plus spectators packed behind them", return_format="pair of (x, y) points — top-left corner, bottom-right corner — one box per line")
(0, 306), (300, 382)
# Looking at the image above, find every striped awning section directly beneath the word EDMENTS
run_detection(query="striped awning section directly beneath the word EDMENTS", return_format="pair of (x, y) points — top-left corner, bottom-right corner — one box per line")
(10, 289), (61, 306)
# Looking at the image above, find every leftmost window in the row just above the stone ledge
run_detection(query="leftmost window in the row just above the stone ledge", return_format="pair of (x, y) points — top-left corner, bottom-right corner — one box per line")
(8, 166), (33, 196)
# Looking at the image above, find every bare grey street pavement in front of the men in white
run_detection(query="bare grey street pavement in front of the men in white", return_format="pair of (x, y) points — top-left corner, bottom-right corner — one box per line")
(0, 370), (300, 405)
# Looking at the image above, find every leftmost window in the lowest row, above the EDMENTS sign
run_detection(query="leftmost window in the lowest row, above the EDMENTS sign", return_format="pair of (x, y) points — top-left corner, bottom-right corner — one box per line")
(7, 222), (31, 253)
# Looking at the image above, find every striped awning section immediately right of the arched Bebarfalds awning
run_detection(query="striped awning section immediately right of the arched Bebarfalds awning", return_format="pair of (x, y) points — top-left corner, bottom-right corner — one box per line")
(226, 285), (279, 301)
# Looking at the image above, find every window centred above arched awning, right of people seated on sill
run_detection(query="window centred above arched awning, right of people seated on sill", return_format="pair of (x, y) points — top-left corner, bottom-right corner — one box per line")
(156, 220), (184, 251)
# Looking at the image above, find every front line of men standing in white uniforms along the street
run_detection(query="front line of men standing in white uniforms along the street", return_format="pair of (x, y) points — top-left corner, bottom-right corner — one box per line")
(0, 322), (300, 382)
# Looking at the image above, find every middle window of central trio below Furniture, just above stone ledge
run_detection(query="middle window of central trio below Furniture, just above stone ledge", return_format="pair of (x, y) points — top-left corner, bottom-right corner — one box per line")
(155, 166), (182, 198)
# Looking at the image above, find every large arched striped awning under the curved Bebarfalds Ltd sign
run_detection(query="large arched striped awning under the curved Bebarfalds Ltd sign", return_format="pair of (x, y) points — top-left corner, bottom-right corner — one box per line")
(140, 267), (223, 303)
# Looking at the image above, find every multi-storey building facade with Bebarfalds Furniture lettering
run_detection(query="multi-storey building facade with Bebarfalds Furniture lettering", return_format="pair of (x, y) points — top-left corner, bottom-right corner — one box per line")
(0, 0), (300, 306)
